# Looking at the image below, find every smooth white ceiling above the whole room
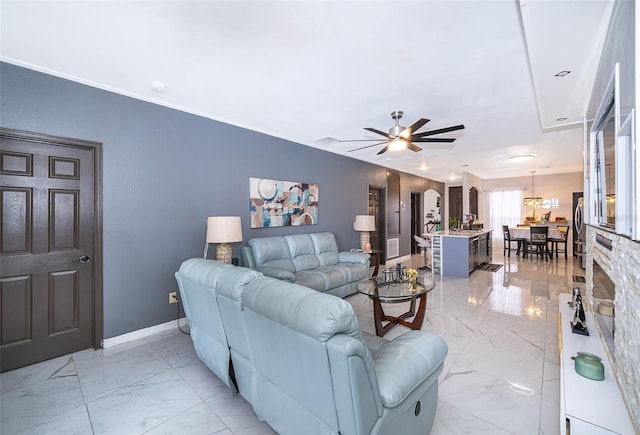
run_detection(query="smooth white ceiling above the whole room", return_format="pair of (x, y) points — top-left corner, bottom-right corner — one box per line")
(0, 0), (613, 182)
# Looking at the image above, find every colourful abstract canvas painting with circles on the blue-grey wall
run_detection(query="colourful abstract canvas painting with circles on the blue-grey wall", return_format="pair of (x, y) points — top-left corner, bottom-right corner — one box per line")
(249, 177), (318, 228)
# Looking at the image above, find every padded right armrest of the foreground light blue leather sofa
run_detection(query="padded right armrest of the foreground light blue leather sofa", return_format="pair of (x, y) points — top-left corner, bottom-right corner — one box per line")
(372, 331), (448, 408)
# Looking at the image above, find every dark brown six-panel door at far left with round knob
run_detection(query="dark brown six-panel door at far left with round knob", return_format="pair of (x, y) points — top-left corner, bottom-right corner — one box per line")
(0, 129), (102, 371)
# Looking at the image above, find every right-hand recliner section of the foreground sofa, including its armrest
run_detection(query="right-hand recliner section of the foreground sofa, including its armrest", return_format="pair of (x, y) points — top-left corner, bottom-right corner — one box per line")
(243, 280), (447, 435)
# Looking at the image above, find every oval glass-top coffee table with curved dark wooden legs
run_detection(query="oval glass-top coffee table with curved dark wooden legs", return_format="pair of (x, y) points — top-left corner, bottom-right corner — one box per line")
(357, 277), (435, 337)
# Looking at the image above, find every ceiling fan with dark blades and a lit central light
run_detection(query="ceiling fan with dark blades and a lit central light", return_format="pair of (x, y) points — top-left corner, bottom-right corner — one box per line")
(339, 110), (464, 154)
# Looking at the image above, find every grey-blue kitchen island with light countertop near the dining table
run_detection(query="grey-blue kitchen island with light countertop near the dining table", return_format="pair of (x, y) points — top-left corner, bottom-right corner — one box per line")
(430, 230), (492, 278)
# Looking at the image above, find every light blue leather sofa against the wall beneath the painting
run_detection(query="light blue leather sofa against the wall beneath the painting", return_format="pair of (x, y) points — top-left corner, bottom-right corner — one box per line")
(242, 232), (370, 297)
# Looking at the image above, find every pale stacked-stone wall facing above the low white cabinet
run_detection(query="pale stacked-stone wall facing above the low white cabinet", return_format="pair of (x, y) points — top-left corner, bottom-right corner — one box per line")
(585, 226), (640, 433)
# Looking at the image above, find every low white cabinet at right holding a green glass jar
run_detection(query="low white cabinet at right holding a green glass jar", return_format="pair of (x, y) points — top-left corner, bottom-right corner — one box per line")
(558, 294), (635, 435)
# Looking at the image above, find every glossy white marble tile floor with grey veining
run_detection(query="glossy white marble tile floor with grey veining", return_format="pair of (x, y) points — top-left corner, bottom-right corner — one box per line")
(0, 249), (584, 435)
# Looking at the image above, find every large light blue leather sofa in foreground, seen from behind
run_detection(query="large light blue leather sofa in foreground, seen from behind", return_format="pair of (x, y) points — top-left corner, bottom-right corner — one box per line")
(176, 258), (447, 435)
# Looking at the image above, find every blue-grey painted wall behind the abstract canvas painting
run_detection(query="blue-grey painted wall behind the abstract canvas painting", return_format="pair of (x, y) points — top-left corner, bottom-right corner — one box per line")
(0, 63), (444, 338)
